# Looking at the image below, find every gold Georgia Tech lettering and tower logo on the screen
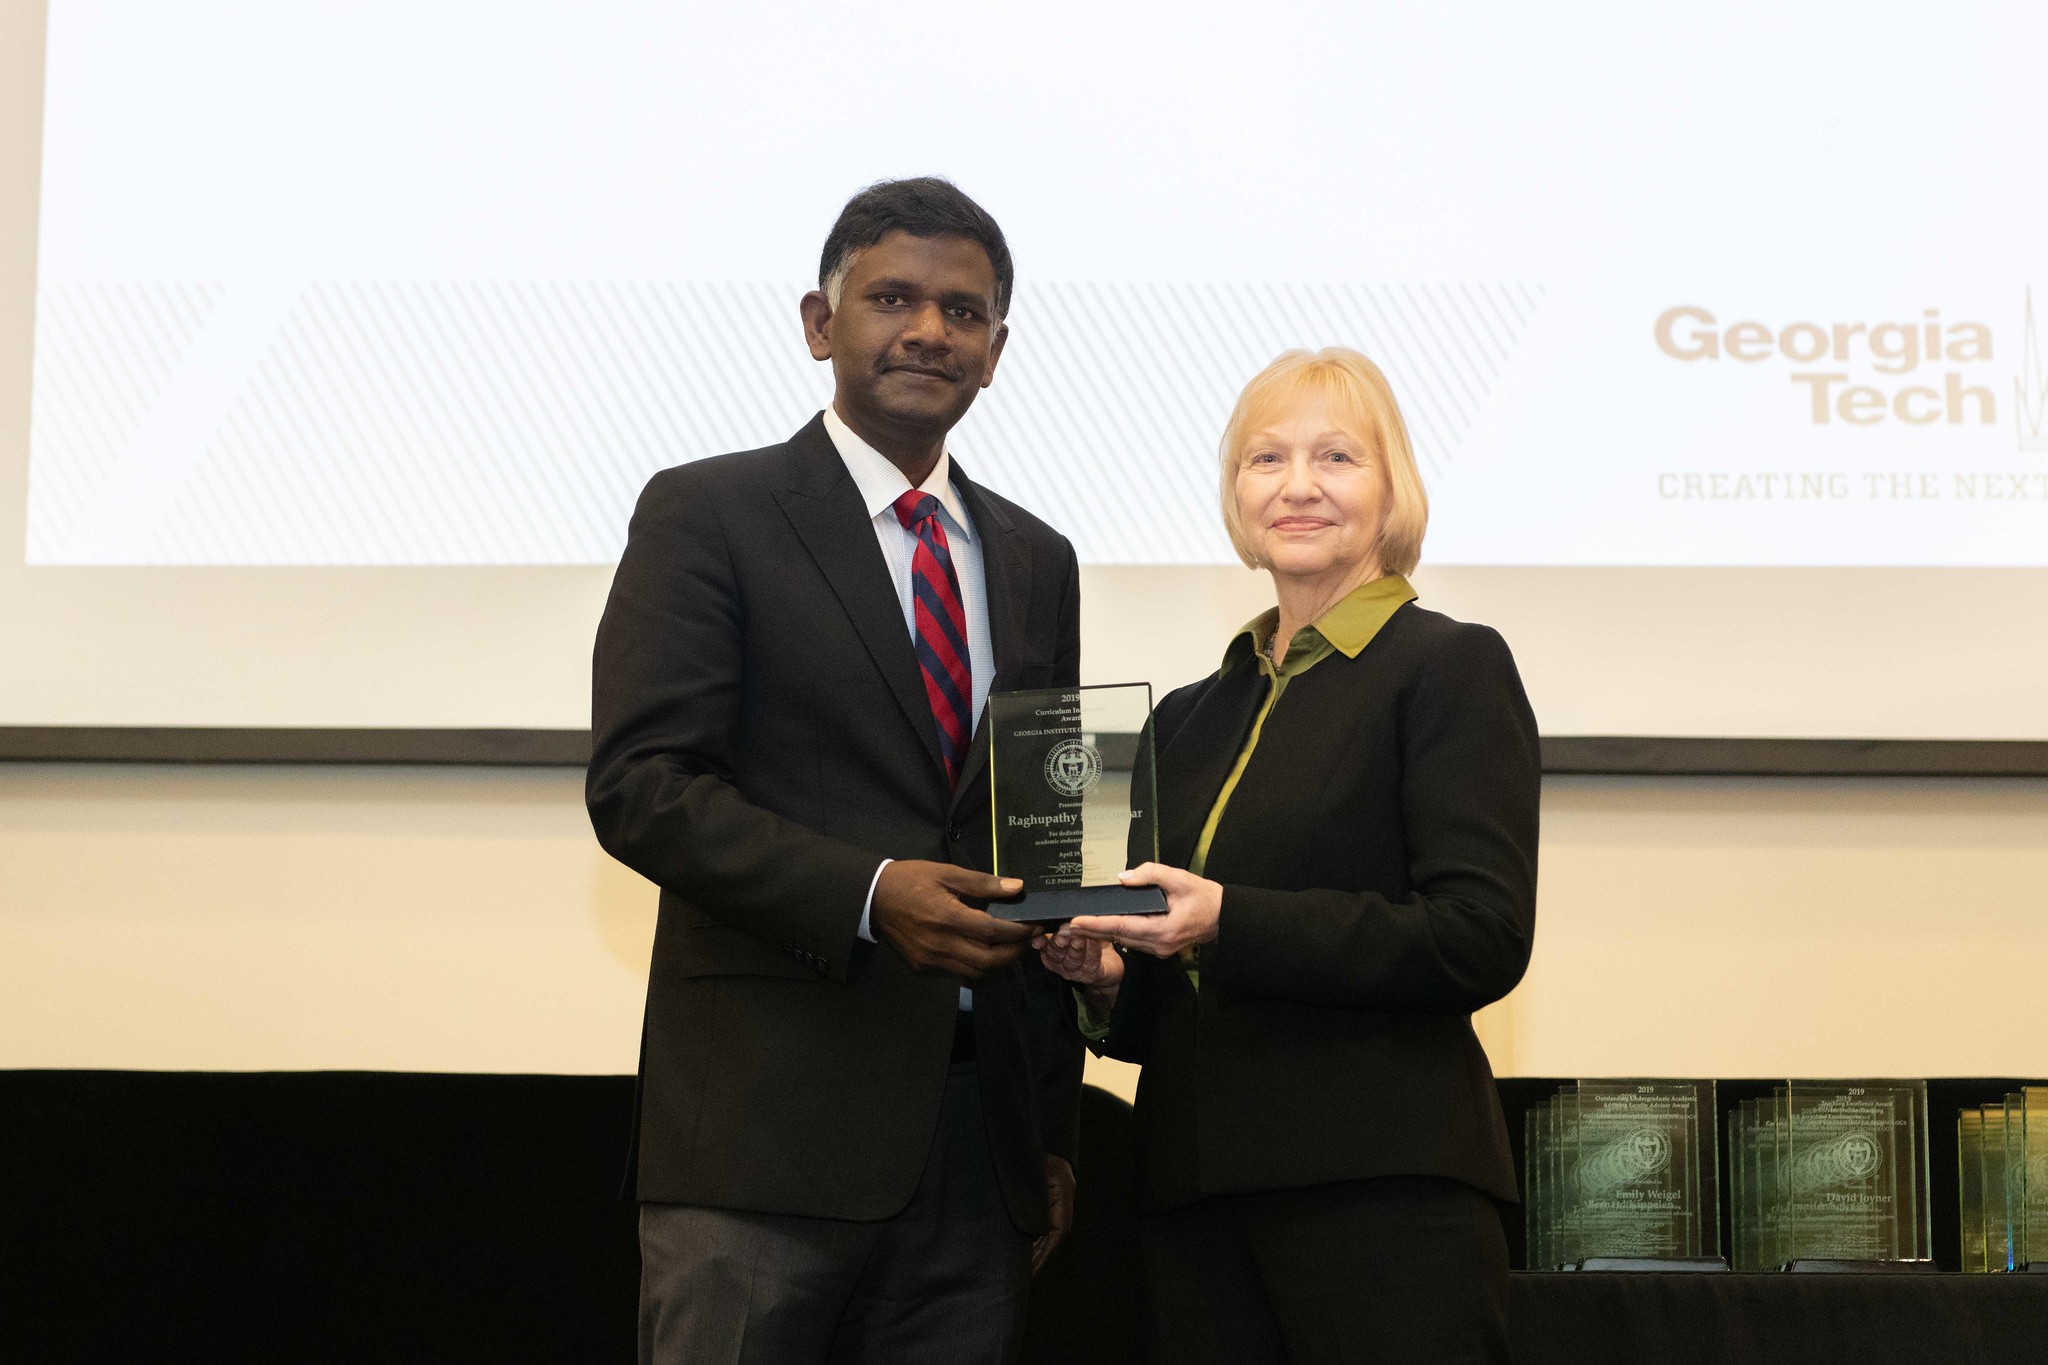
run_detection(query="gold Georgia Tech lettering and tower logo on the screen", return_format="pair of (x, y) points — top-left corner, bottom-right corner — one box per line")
(1653, 289), (2048, 450)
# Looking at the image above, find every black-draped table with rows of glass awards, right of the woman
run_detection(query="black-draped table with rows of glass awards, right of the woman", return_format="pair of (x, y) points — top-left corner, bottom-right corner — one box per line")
(1499, 1076), (2048, 1365)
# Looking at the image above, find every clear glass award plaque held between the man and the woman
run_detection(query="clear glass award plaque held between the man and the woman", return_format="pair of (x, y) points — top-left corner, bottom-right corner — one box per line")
(989, 684), (1165, 923)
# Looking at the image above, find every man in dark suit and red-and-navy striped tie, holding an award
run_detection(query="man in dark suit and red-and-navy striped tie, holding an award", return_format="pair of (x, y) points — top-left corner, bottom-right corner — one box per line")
(588, 180), (1081, 1365)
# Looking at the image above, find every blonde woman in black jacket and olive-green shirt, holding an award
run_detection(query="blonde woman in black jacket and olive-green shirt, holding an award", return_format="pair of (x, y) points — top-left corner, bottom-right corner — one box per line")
(1036, 348), (1540, 1365)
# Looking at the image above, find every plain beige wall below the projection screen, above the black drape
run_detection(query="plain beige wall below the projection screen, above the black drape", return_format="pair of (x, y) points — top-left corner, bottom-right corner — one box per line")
(0, 765), (2048, 1091)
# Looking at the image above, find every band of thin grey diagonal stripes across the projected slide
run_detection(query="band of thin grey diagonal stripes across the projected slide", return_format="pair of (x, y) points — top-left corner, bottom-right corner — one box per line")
(29, 280), (1540, 565)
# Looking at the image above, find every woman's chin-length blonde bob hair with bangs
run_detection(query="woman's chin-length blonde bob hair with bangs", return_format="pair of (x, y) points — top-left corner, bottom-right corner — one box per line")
(1221, 346), (1430, 575)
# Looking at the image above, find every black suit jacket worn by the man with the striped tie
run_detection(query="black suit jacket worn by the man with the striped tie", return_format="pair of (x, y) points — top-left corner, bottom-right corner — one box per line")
(588, 415), (1081, 1232)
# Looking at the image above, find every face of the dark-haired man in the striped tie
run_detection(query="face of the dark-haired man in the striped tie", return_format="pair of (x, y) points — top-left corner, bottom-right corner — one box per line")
(803, 231), (1008, 438)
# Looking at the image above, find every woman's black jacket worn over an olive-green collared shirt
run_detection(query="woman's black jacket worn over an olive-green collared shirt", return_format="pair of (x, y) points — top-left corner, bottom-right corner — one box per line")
(1104, 602), (1542, 1205)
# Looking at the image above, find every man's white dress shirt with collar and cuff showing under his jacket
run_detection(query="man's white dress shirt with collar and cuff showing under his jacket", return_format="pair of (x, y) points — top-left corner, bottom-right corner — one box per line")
(825, 405), (995, 1009)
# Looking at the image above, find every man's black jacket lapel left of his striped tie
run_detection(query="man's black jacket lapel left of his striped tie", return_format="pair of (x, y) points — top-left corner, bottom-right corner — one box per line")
(776, 413), (950, 774)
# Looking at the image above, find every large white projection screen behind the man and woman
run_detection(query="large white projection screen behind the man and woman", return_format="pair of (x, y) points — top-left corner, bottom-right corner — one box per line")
(0, 0), (2048, 739)
